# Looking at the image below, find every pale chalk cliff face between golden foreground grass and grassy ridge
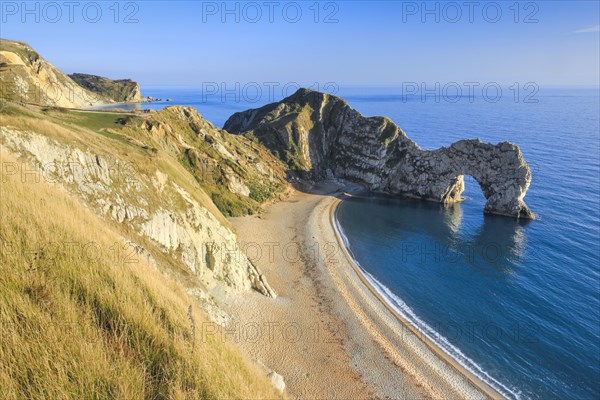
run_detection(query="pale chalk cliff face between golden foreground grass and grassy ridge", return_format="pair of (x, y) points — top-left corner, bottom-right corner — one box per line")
(0, 126), (275, 297)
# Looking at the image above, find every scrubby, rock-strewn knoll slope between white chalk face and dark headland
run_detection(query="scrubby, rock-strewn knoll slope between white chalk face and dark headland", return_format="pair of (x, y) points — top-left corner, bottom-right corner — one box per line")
(131, 106), (287, 216)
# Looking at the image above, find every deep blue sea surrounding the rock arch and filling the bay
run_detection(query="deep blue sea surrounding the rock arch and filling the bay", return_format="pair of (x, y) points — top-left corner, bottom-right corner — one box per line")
(91, 84), (600, 399)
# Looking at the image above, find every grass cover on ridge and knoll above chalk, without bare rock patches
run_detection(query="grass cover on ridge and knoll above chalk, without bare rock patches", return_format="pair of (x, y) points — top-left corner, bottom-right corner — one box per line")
(2, 103), (286, 217)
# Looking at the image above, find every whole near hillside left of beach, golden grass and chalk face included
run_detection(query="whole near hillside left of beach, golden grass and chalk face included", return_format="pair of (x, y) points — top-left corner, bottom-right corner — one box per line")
(0, 99), (285, 399)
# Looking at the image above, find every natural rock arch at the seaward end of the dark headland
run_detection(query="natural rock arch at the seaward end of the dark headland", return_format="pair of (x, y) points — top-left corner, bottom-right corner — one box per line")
(387, 139), (534, 219)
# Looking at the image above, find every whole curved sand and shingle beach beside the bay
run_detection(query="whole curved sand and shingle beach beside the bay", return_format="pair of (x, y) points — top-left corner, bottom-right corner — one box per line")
(225, 186), (502, 400)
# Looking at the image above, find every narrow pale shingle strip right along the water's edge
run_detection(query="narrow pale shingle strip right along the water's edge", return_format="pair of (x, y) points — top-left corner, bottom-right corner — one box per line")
(329, 194), (505, 400)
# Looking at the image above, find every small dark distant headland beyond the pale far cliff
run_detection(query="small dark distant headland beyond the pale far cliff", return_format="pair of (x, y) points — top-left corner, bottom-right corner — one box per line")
(69, 74), (143, 103)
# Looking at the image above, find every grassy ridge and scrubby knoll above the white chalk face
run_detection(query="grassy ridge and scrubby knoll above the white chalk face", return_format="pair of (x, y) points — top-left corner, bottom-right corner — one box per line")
(2, 103), (287, 217)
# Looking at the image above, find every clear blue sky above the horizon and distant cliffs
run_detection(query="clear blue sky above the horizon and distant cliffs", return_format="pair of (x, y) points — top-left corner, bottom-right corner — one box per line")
(0, 0), (600, 86)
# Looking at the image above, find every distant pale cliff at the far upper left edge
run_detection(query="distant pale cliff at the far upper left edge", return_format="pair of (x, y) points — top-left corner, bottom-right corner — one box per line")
(0, 39), (105, 108)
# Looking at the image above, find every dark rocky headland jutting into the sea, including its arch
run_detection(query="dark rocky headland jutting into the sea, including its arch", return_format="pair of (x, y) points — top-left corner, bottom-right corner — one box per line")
(224, 89), (534, 218)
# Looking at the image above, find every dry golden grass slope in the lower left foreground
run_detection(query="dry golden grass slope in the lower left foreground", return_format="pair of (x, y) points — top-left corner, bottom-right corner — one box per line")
(0, 148), (280, 400)
